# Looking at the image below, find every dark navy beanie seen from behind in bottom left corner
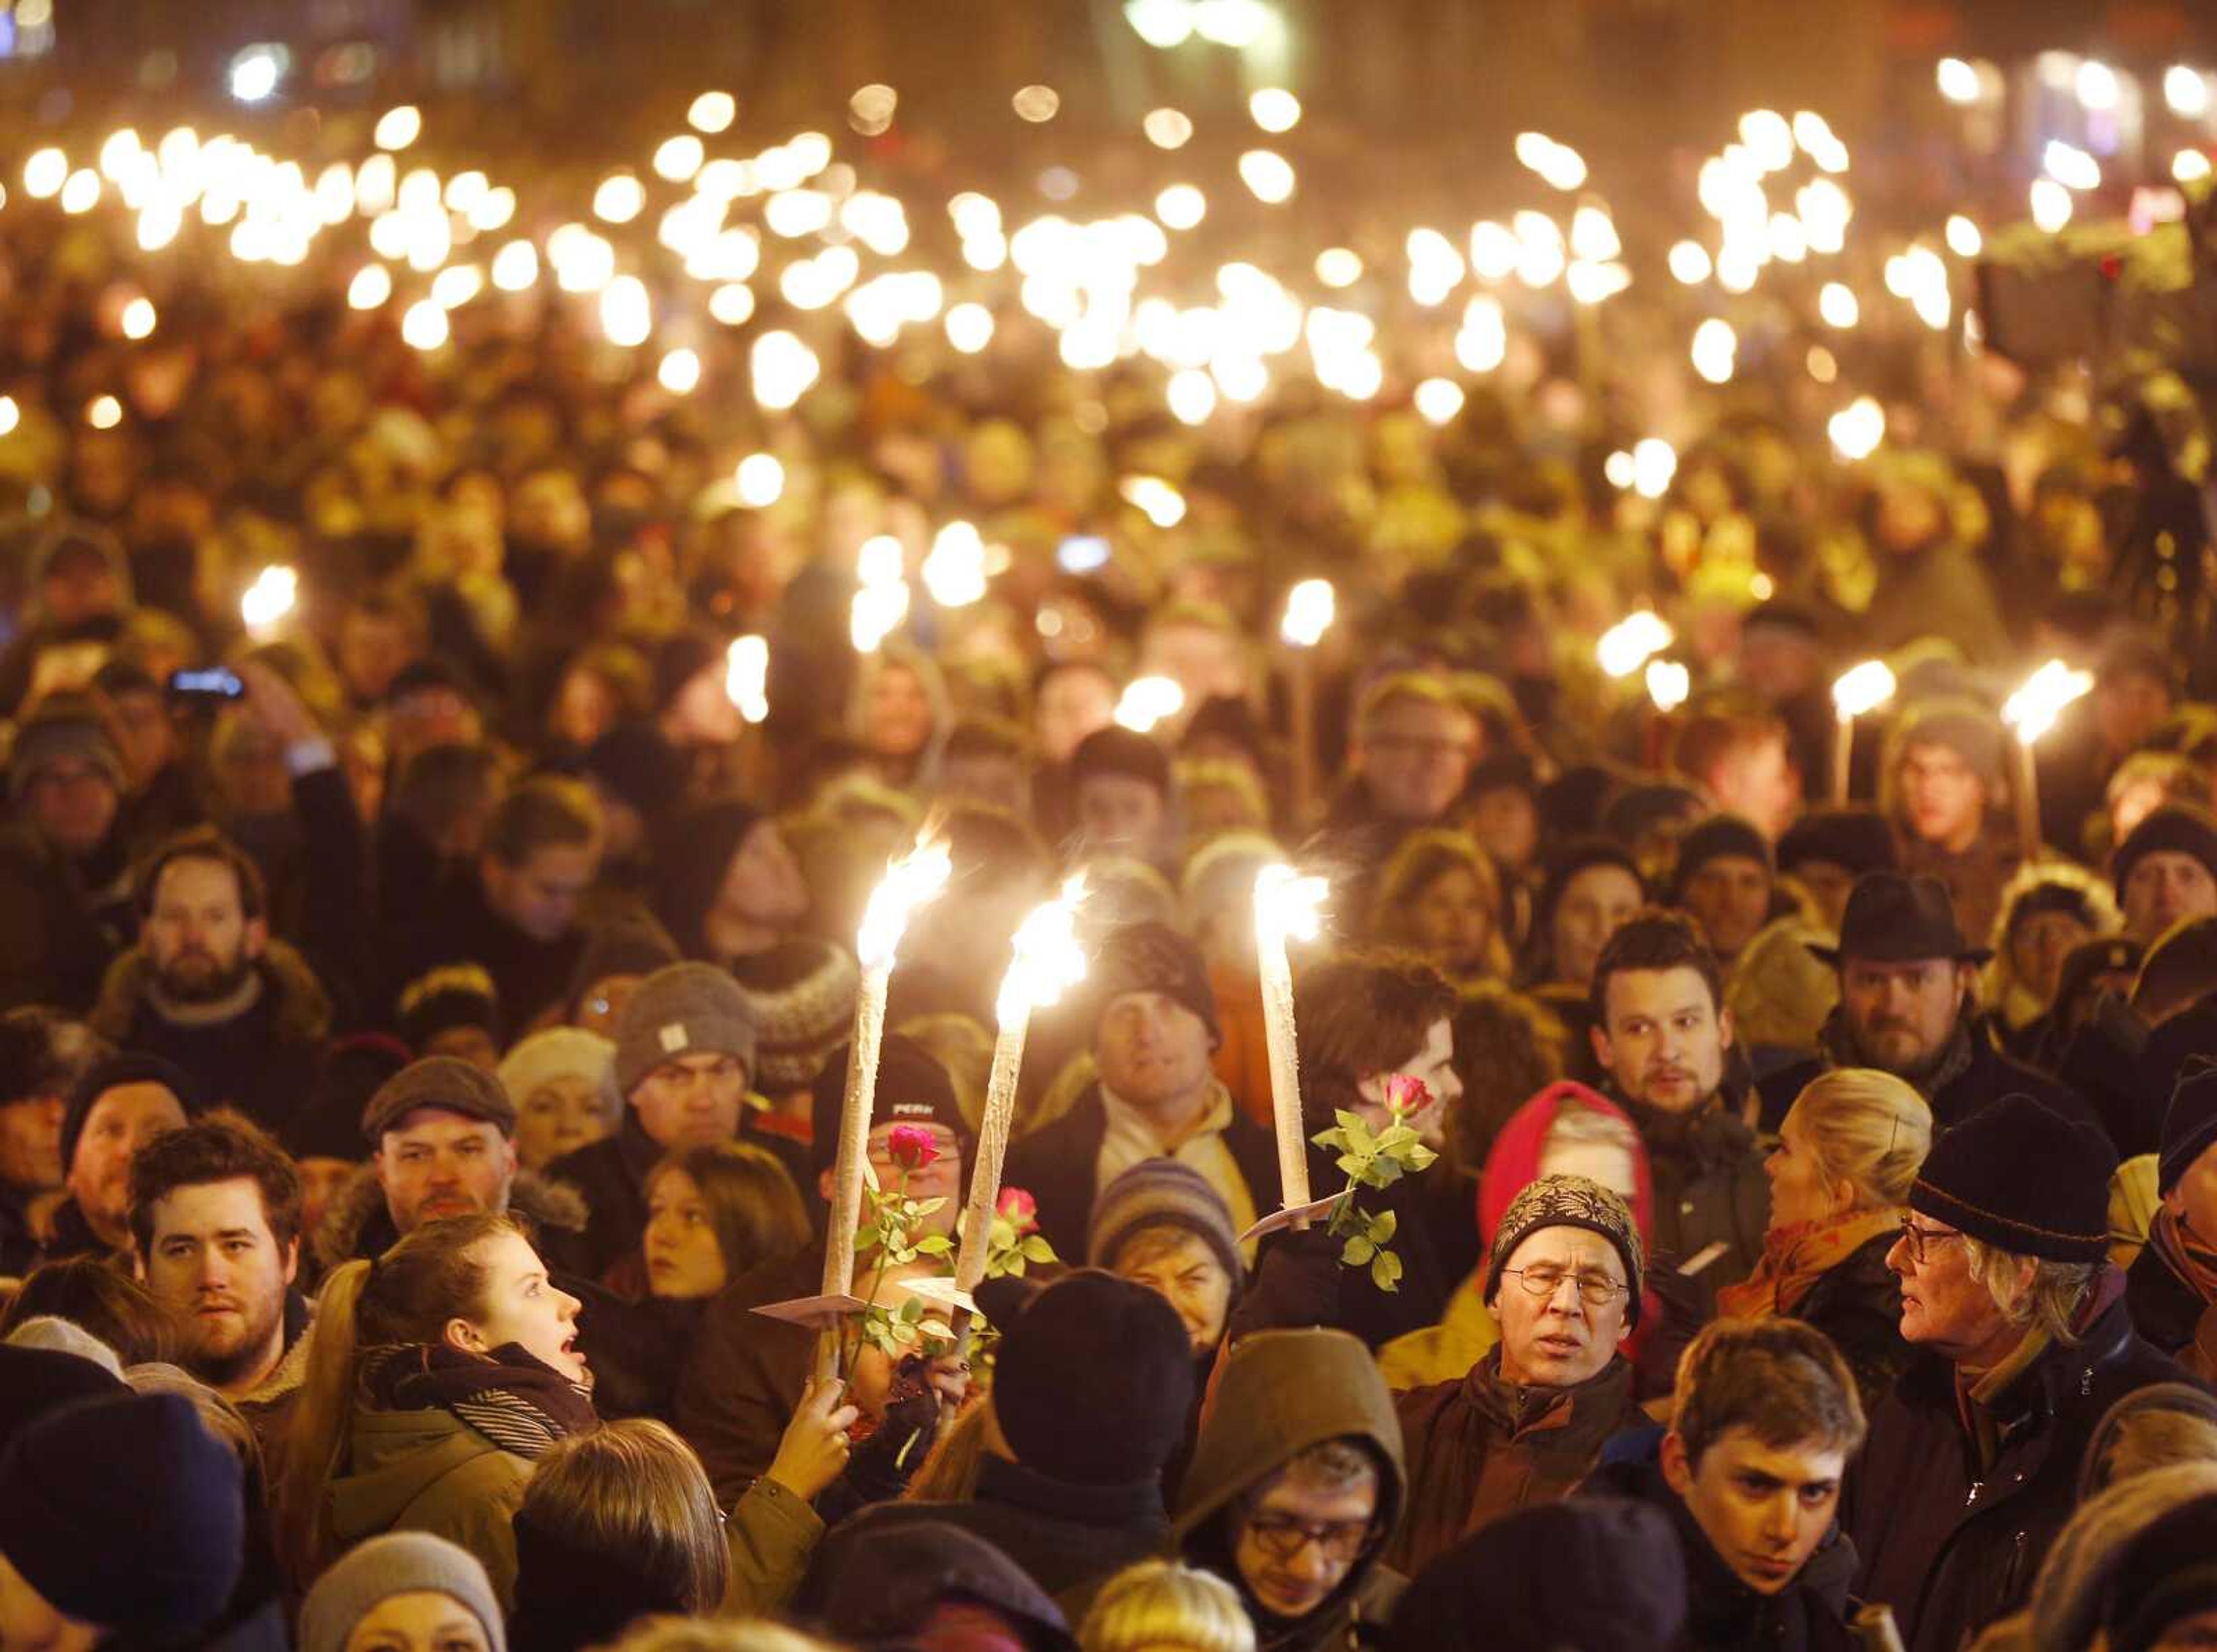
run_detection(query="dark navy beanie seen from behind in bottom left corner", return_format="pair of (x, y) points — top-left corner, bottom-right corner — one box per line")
(0, 1395), (246, 1643)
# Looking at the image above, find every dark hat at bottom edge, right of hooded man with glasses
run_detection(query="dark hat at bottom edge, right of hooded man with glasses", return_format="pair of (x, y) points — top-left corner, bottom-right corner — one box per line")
(1386, 1497), (1687, 1652)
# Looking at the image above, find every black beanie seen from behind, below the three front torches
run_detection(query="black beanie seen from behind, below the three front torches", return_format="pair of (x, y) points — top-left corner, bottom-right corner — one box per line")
(976, 1269), (1193, 1486)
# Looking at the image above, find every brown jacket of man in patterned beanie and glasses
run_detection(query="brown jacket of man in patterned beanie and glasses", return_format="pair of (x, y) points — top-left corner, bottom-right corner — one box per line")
(1386, 1348), (1647, 1576)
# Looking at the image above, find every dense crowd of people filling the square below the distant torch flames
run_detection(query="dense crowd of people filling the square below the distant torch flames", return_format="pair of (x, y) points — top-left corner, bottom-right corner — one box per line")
(0, 90), (2217, 1652)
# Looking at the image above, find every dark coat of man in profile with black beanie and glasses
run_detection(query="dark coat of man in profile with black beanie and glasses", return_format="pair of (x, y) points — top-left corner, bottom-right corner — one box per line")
(1840, 1299), (2186, 1652)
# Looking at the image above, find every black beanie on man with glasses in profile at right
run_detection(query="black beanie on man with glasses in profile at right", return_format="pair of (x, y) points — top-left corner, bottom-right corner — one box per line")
(1909, 1095), (2117, 1262)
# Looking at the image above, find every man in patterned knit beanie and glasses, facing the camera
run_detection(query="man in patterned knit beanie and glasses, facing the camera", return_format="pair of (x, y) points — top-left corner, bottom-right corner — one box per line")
(1386, 1175), (1647, 1575)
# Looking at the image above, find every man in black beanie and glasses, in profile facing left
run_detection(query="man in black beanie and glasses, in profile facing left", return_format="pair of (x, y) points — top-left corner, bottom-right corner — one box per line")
(1842, 1095), (2186, 1652)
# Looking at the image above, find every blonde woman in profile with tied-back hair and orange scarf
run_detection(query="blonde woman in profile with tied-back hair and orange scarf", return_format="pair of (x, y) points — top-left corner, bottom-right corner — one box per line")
(1716, 1066), (1933, 1406)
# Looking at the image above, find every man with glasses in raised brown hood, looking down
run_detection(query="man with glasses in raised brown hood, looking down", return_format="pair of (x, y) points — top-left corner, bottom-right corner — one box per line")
(1173, 1328), (1404, 1652)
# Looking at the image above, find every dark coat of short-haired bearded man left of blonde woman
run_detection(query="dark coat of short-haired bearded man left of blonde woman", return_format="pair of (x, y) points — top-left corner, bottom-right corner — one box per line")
(1610, 1093), (1771, 1319)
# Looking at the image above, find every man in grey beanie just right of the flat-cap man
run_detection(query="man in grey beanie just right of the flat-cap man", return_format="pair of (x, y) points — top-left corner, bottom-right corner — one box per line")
(547, 963), (754, 1280)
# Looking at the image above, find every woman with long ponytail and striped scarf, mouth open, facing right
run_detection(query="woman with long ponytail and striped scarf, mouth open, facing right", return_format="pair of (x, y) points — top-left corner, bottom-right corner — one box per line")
(275, 1215), (596, 1608)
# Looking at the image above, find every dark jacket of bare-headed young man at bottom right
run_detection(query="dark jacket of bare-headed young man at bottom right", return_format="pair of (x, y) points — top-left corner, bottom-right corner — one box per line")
(1578, 1428), (1860, 1652)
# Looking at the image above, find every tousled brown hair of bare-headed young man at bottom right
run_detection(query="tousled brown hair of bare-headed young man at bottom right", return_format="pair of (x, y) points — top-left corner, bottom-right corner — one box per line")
(1671, 1319), (1864, 1465)
